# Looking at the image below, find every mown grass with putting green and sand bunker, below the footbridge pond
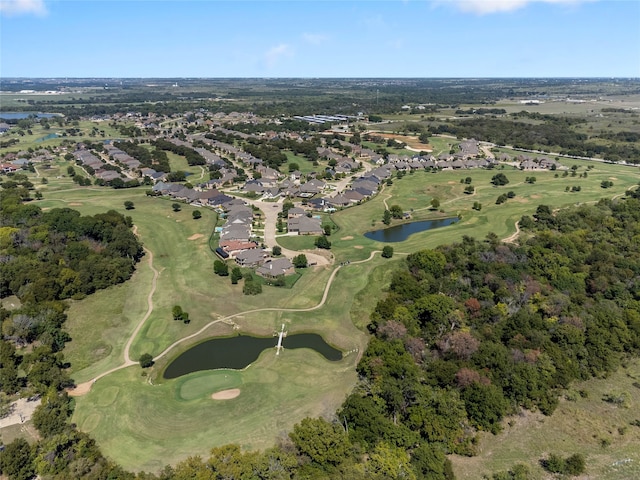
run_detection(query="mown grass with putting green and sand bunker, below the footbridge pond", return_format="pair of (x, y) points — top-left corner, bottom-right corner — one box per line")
(73, 344), (355, 470)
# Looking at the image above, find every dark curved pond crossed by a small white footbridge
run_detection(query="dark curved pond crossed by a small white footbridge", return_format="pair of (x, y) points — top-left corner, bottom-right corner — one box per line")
(163, 333), (342, 379)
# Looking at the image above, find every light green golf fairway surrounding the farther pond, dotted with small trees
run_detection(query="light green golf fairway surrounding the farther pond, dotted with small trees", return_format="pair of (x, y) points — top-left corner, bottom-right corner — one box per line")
(278, 159), (640, 261)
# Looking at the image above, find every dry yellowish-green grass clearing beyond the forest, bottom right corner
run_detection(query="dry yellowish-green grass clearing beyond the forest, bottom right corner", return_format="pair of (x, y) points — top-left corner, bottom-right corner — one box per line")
(451, 360), (640, 480)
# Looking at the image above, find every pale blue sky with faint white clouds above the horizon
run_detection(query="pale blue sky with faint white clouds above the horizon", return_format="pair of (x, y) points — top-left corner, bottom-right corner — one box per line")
(0, 0), (640, 77)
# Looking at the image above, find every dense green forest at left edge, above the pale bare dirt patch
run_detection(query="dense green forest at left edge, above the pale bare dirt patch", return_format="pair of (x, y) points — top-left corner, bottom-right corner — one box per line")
(0, 189), (143, 398)
